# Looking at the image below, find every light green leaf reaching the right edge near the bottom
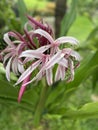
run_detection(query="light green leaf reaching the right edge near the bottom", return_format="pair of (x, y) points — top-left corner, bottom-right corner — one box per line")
(63, 102), (98, 119)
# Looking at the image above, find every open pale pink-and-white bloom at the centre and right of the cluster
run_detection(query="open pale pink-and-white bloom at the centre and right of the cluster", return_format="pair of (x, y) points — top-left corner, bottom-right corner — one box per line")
(16, 29), (81, 88)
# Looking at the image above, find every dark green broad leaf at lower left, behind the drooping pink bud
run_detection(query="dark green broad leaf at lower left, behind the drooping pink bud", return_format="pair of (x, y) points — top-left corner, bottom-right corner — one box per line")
(0, 74), (39, 112)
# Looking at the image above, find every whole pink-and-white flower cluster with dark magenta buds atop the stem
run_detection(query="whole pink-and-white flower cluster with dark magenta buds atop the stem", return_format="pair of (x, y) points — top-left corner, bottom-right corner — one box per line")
(1, 16), (81, 101)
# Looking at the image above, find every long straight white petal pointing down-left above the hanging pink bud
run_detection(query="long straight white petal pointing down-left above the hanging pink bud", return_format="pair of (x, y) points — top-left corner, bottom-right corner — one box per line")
(16, 60), (41, 85)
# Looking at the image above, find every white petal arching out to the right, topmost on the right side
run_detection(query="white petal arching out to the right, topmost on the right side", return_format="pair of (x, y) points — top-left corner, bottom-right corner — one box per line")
(55, 36), (79, 45)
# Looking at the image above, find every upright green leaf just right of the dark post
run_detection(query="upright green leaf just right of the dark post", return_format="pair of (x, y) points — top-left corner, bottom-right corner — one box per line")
(60, 0), (77, 36)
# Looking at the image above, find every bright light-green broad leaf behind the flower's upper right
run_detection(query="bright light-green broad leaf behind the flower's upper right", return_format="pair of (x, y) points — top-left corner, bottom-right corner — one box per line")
(67, 15), (94, 42)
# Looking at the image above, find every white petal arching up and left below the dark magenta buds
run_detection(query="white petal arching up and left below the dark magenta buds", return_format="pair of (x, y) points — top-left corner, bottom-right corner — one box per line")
(34, 29), (54, 44)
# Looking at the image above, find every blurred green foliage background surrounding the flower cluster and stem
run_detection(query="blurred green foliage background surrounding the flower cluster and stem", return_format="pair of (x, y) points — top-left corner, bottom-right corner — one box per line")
(0, 0), (98, 130)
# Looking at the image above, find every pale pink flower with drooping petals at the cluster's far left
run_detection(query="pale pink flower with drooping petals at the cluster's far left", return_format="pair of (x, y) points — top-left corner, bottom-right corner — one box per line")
(1, 33), (24, 81)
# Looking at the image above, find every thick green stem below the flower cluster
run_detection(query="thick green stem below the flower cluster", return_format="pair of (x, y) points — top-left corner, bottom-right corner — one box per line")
(34, 86), (48, 128)
